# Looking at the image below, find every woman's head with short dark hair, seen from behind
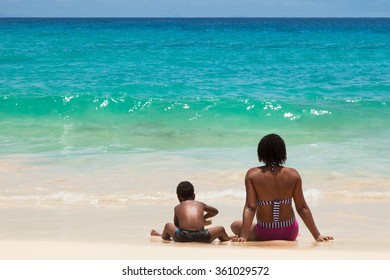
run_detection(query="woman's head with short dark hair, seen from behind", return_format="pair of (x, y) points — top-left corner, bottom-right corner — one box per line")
(257, 134), (287, 165)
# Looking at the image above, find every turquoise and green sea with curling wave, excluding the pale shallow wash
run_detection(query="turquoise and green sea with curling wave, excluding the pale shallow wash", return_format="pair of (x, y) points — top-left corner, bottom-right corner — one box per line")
(0, 19), (390, 154)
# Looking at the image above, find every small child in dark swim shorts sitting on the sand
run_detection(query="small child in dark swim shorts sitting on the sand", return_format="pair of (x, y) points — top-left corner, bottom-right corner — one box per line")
(150, 181), (231, 243)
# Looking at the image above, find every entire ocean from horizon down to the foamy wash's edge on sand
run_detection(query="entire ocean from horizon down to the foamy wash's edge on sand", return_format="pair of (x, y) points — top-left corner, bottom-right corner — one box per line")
(0, 18), (390, 244)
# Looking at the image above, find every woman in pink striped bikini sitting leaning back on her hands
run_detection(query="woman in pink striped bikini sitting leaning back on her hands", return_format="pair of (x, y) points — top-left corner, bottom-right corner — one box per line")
(231, 134), (333, 242)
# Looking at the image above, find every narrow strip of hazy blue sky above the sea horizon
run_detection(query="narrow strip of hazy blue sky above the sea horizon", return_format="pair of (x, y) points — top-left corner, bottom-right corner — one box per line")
(0, 0), (390, 17)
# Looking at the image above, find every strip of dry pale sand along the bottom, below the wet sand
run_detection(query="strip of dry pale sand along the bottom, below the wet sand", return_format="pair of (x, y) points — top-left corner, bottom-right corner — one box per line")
(0, 237), (390, 260)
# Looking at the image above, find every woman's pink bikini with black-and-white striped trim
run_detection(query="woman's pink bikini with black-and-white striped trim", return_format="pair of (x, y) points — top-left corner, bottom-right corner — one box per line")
(253, 198), (299, 241)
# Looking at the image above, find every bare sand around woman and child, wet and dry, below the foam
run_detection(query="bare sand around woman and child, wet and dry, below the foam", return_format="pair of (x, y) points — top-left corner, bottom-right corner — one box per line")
(0, 199), (390, 260)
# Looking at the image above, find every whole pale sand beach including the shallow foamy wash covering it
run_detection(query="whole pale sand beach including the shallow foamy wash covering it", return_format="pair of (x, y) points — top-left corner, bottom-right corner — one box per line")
(0, 150), (390, 260)
